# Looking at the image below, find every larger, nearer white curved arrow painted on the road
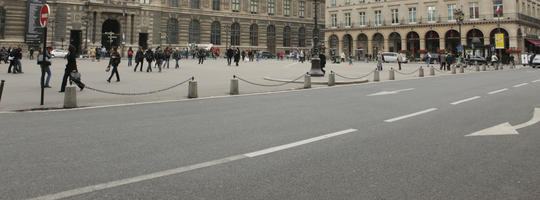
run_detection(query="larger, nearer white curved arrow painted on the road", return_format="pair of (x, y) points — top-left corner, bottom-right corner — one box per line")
(465, 108), (540, 136)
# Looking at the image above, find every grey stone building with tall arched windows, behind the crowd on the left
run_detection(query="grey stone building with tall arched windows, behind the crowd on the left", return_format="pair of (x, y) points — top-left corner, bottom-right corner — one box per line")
(0, 0), (325, 52)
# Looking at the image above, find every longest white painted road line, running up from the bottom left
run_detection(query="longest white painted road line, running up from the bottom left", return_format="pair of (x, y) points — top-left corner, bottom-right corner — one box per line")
(28, 129), (358, 200)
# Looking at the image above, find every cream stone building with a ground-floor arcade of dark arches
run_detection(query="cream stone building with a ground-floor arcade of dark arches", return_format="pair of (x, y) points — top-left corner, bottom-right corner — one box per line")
(325, 0), (540, 57)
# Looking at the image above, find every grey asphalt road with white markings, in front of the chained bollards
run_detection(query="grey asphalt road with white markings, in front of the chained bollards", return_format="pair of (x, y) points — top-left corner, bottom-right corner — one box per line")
(0, 69), (540, 200)
